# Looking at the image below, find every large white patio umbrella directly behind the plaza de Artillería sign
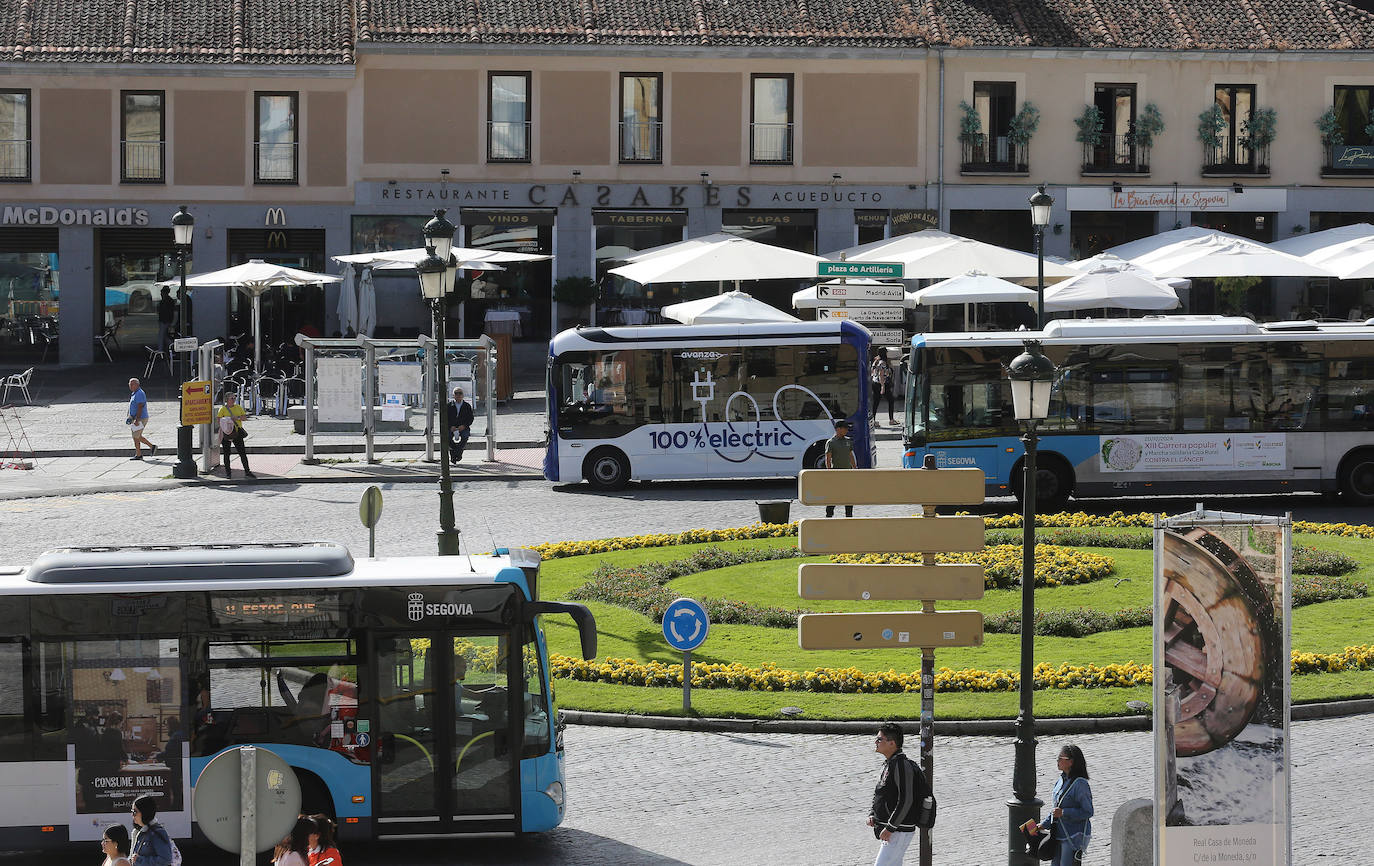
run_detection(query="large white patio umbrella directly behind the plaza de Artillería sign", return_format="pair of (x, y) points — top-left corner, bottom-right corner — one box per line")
(829, 228), (1076, 283)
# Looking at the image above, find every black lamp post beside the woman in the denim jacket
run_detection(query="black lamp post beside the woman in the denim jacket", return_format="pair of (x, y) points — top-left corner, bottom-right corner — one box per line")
(1007, 340), (1055, 866)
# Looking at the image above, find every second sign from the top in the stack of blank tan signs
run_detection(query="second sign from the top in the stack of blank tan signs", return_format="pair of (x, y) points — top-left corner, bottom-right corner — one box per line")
(797, 516), (984, 554)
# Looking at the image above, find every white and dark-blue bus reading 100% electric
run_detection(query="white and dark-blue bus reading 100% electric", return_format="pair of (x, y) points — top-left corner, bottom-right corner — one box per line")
(544, 322), (875, 489)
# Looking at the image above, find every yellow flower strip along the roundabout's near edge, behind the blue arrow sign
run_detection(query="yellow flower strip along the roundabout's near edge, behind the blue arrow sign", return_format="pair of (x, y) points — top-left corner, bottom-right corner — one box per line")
(550, 646), (1374, 694)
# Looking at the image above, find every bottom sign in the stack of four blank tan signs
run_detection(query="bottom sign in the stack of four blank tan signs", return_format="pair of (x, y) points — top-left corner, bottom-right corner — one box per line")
(797, 610), (982, 650)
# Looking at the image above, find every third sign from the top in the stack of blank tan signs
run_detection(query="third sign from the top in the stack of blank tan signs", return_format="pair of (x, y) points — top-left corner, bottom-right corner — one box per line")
(797, 562), (982, 601)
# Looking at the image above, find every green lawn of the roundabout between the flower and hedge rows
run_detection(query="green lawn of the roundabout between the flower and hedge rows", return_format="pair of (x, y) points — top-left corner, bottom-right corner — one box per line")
(541, 535), (1374, 719)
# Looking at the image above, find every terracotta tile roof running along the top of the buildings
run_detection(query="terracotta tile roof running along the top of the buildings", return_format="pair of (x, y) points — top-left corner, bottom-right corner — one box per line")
(0, 0), (1374, 65)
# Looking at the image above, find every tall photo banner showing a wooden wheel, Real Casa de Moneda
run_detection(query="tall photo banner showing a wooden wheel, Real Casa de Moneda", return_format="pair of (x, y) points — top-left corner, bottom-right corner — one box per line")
(1154, 511), (1292, 866)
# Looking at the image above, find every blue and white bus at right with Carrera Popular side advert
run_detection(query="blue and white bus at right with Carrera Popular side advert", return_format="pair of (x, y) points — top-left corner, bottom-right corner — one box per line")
(903, 316), (1374, 507)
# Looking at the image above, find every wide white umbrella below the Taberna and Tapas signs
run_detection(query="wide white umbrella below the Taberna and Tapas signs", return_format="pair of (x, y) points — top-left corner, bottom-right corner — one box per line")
(610, 234), (822, 291)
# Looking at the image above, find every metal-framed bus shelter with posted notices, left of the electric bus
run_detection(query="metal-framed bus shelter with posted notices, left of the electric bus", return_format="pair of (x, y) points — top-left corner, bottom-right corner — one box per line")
(295, 334), (497, 463)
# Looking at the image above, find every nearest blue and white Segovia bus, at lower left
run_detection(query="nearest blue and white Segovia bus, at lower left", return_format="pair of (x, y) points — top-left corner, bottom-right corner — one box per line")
(0, 543), (596, 850)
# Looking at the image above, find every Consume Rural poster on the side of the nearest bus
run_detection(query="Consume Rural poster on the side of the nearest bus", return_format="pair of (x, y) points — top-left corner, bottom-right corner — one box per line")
(69, 657), (187, 819)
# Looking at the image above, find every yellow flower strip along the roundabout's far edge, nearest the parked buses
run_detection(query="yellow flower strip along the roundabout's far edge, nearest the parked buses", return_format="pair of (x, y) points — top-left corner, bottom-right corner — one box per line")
(530, 511), (1374, 559)
